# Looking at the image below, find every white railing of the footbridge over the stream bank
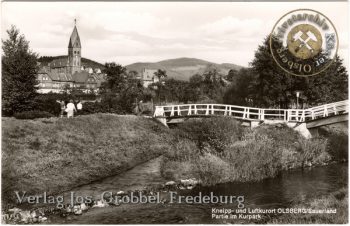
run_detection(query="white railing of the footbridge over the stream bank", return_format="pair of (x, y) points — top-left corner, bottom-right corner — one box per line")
(153, 100), (348, 122)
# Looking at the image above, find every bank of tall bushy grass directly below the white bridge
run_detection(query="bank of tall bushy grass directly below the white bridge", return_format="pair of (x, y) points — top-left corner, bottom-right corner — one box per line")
(162, 117), (347, 185)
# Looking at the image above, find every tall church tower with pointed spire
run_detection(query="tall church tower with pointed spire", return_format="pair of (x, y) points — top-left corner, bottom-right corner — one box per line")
(68, 19), (81, 74)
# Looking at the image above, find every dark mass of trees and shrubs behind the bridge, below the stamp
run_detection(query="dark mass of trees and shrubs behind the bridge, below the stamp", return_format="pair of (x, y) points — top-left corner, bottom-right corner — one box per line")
(224, 37), (348, 108)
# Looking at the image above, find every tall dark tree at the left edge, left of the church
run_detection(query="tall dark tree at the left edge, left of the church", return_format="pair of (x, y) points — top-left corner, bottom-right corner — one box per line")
(1, 26), (38, 116)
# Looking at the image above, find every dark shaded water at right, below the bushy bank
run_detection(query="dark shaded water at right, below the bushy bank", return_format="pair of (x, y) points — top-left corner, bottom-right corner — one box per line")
(186, 164), (348, 208)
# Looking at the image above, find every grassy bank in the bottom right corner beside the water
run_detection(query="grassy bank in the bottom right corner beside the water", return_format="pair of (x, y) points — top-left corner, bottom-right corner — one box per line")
(264, 188), (348, 224)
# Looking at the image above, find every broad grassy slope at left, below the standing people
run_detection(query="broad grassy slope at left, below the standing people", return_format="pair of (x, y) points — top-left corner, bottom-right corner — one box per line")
(2, 114), (169, 207)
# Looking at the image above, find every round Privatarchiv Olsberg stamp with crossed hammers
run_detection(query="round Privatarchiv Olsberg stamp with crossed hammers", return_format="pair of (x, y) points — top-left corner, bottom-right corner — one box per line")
(270, 9), (339, 77)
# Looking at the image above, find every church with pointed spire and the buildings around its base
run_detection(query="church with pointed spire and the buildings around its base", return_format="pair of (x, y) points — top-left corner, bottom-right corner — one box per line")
(37, 19), (105, 93)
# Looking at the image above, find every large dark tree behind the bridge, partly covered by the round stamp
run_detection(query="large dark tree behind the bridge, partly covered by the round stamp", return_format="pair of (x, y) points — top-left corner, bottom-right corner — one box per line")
(250, 37), (348, 108)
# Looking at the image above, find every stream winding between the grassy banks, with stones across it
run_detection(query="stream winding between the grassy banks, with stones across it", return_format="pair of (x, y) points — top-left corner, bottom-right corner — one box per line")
(48, 157), (348, 224)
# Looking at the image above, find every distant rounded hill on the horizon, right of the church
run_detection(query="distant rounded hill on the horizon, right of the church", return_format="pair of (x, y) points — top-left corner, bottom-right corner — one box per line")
(126, 58), (242, 81)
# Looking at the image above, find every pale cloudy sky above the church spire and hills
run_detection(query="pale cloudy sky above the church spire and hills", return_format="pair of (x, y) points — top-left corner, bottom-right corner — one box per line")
(1, 2), (349, 66)
